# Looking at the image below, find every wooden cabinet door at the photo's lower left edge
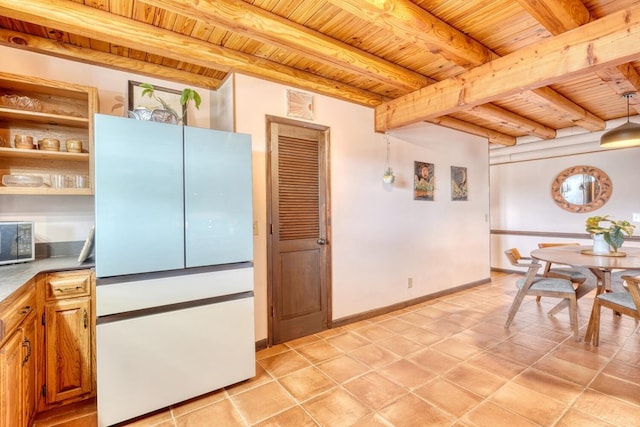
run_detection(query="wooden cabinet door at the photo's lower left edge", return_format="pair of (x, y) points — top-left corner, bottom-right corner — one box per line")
(0, 329), (25, 427)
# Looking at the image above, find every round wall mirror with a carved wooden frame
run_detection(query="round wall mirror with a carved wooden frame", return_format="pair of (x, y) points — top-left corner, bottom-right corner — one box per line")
(551, 166), (613, 213)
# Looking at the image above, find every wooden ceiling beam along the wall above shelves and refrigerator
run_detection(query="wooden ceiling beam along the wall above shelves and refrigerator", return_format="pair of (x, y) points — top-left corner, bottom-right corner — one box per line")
(0, 29), (222, 90)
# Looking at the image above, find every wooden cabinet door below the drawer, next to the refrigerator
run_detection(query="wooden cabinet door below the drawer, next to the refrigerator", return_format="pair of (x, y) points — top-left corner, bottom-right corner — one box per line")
(45, 297), (92, 404)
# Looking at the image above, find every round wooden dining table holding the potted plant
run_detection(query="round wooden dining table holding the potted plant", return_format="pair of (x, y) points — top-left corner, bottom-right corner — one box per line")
(531, 245), (640, 291)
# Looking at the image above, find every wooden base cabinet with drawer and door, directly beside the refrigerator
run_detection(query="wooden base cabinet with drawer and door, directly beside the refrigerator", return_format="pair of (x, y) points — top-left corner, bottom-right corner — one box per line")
(38, 270), (96, 411)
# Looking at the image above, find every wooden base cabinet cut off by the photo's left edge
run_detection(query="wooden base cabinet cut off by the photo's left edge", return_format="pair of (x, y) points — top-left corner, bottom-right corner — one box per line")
(0, 284), (38, 427)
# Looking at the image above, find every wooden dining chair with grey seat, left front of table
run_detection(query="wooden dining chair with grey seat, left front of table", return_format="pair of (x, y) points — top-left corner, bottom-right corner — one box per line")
(504, 248), (580, 341)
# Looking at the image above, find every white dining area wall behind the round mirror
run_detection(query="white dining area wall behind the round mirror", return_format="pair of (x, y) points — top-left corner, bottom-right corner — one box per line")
(490, 137), (640, 269)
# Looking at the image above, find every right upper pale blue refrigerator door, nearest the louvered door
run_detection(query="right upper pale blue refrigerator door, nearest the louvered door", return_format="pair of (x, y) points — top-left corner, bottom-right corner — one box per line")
(184, 127), (253, 267)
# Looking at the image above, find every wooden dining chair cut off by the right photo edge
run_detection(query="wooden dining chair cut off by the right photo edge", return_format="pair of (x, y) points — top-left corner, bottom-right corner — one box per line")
(584, 276), (640, 347)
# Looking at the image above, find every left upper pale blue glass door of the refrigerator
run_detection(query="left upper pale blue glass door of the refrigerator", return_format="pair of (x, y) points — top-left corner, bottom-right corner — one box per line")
(94, 114), (184, 277)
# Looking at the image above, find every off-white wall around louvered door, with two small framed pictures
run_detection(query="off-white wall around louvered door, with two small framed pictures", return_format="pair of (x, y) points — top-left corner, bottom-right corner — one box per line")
(235, 75), (489, 339)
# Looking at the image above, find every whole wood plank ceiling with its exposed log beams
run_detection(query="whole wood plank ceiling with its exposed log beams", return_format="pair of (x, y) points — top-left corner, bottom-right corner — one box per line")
(0, 0), (640, 145)
